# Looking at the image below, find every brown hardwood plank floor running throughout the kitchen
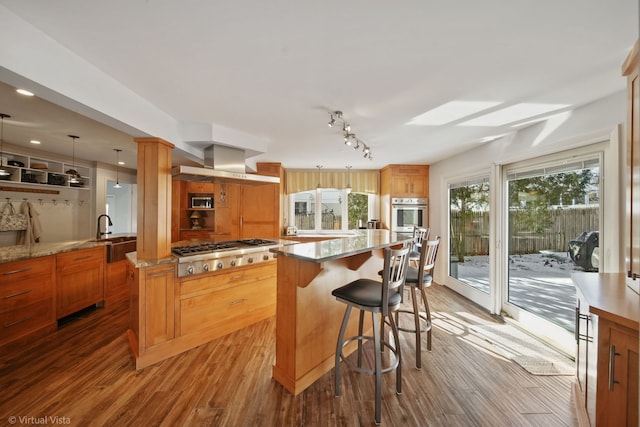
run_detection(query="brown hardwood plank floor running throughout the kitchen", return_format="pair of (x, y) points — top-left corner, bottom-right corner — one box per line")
(0, 285), (578, 427)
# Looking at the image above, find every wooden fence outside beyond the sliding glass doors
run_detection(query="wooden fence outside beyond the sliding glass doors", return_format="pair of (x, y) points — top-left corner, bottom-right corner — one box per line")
(451, 206), (599, 255)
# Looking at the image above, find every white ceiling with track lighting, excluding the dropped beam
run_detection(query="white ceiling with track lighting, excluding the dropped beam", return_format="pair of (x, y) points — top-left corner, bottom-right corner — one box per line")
(0, 0), (638, 169)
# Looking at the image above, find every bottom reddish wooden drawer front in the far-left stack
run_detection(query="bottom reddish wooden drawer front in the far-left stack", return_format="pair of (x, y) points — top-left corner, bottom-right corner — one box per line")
(0, 298), (55, 343)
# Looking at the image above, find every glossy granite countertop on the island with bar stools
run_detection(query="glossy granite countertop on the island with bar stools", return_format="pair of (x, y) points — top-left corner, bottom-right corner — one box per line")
(271, 230), (412, 262)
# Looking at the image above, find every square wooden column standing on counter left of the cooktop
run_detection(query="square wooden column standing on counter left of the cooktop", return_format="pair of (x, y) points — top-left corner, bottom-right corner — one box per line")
(134, 138), (174, 261)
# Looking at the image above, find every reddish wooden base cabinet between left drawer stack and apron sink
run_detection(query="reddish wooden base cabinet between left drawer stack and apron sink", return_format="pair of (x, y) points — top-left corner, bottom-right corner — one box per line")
(56, 246), (106, 319)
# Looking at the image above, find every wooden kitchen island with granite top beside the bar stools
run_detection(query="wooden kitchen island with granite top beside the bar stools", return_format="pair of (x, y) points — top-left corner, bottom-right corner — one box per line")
(272, 230), (411, 394)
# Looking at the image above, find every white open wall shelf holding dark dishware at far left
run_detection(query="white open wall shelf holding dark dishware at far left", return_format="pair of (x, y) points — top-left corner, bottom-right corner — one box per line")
(0, 152), (91, 189)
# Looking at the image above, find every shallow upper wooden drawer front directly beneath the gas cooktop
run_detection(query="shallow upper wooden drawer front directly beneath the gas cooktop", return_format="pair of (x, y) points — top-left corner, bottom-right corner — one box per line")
(180, 261), (277, 296)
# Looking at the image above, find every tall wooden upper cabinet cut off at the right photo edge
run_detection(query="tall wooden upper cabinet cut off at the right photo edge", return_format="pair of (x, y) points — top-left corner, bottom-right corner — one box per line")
(622, 41), (640, 287)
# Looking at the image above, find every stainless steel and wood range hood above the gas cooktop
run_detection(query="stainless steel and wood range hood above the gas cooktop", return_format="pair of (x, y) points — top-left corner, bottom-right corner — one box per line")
(172, 144), (280, 185)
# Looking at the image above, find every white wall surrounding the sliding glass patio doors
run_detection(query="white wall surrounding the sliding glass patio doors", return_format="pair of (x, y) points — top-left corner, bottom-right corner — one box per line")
(429, 91), (627, 283)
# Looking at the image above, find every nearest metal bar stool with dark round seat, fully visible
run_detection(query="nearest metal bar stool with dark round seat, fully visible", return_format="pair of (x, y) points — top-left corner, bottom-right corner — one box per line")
(331, 246), (410, 424)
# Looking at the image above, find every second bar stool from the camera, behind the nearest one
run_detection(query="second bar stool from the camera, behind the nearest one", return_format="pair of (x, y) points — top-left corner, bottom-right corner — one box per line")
(395, 236), (440, 369)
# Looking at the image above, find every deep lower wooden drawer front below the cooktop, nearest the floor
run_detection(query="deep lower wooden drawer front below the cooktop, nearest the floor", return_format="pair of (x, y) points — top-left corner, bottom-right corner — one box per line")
(180, 281), (276, 336)
